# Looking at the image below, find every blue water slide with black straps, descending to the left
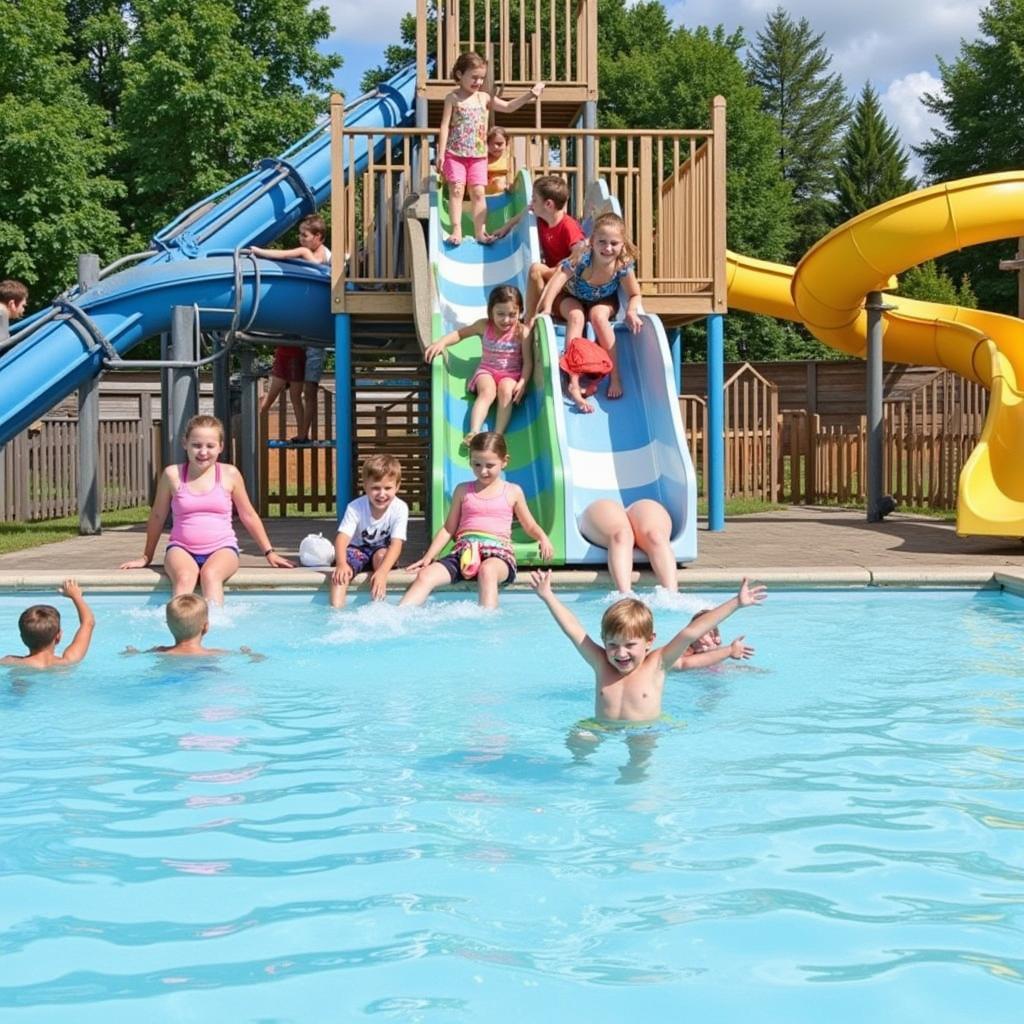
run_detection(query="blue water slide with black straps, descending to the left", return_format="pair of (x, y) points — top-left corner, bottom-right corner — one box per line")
(0, 68), (416, 444)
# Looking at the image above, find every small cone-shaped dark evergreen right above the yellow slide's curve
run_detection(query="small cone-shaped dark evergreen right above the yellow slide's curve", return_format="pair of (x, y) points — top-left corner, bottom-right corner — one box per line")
(836, 82), (914, 221)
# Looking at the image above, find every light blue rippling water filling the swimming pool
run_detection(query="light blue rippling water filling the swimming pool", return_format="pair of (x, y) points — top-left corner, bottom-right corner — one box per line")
(0, 591), (1024, 1024)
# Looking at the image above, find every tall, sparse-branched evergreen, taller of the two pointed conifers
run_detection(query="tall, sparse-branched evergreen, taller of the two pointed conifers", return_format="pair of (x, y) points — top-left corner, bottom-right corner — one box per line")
(748, 7), (849, 260)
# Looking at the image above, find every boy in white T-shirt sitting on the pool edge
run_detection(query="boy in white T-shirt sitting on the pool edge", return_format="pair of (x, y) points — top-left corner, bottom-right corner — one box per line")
(331, 455), (409, 608)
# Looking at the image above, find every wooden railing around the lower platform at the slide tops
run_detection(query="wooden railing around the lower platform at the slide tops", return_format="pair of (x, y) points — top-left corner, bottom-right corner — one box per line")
(332, 117), (726, 312)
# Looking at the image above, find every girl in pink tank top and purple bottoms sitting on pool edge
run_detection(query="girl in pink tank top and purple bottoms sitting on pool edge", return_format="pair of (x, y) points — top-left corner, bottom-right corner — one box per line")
(121, 416), (293, 604)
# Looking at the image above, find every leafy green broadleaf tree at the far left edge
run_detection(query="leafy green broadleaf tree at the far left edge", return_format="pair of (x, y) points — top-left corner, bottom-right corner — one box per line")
(0, 0), (123, 300)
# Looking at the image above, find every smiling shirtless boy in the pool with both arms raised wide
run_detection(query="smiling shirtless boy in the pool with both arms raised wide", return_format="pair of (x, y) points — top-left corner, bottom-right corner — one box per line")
(529, 570), (767, 722)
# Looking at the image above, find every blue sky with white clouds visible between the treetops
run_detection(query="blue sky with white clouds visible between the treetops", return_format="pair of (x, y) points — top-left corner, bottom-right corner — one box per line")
(325, 0), (987, 172)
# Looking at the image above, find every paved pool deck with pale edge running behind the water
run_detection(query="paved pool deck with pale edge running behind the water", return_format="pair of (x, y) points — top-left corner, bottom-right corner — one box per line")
(0, 507), (1024, 595)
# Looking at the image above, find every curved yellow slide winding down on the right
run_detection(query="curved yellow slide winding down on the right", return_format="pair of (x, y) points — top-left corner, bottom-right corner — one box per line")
(727, 171), (1024, 537)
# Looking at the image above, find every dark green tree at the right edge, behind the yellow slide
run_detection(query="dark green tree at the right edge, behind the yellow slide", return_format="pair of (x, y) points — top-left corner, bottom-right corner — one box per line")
(916, 0), (1024, 313)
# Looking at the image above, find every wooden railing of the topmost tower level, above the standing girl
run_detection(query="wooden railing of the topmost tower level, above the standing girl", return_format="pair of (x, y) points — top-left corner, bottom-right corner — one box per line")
(416, 0), (597, 97)
